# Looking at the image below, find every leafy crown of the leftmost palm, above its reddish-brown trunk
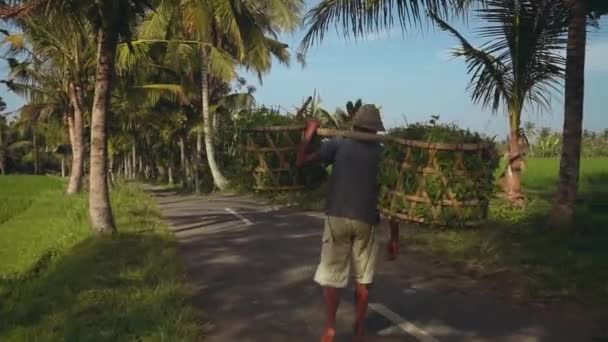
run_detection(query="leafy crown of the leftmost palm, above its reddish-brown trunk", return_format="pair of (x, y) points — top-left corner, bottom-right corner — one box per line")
(2, 14), (95, 117)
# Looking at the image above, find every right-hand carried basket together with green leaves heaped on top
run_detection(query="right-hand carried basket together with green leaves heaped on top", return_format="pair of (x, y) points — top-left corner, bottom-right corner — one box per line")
(379, 123), (498, 226)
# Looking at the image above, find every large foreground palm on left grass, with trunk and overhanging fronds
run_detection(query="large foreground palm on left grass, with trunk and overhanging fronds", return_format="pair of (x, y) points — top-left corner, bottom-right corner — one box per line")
(0, 0), (154, 234)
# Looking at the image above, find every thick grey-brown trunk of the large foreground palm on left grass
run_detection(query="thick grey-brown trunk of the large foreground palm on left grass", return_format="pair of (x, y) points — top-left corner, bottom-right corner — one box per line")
(89, 10), (118, 234)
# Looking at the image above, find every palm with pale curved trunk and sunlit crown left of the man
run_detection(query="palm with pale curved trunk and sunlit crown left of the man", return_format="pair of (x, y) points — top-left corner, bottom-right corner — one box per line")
(184, 0), (303, 190)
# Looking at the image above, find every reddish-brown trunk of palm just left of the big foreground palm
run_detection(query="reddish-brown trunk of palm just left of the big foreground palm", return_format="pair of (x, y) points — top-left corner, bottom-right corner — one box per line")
(66, 83), (84, 195)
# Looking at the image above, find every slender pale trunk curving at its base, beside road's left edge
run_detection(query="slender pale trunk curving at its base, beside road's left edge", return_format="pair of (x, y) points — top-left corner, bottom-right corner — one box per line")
(201, 49), (228, 191)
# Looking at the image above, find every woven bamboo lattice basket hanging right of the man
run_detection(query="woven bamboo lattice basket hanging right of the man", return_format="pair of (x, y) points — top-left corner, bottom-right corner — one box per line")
(379, 139), (493, 227)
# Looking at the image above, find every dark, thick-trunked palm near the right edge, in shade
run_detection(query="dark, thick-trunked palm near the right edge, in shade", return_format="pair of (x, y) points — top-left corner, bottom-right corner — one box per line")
(552, 0), (608, 225)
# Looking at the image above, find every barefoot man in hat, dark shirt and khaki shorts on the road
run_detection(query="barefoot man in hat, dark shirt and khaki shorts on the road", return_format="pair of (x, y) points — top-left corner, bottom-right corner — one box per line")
(296, 105), (398, 342)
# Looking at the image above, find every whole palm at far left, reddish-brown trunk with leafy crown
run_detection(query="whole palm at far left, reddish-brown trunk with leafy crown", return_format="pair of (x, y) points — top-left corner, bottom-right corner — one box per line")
(4, 14), (95, 194)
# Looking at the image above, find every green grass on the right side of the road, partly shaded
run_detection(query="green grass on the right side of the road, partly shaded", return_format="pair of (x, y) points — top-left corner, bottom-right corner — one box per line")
(405, 158), (608, 306)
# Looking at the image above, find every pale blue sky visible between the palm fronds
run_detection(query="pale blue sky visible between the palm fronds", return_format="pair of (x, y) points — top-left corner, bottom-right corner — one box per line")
(0, 11), (608, 137)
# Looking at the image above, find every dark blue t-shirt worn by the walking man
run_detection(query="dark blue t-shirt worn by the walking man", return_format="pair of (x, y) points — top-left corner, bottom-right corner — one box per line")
(319, 138), (382, 224)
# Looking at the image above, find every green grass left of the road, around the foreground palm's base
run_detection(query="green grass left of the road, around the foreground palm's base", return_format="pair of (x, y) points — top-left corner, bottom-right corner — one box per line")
(0, 177), (202, 342)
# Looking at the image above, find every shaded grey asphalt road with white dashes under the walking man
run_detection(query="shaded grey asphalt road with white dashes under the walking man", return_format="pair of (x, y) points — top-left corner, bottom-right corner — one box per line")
(151, 189), (592, 342)
